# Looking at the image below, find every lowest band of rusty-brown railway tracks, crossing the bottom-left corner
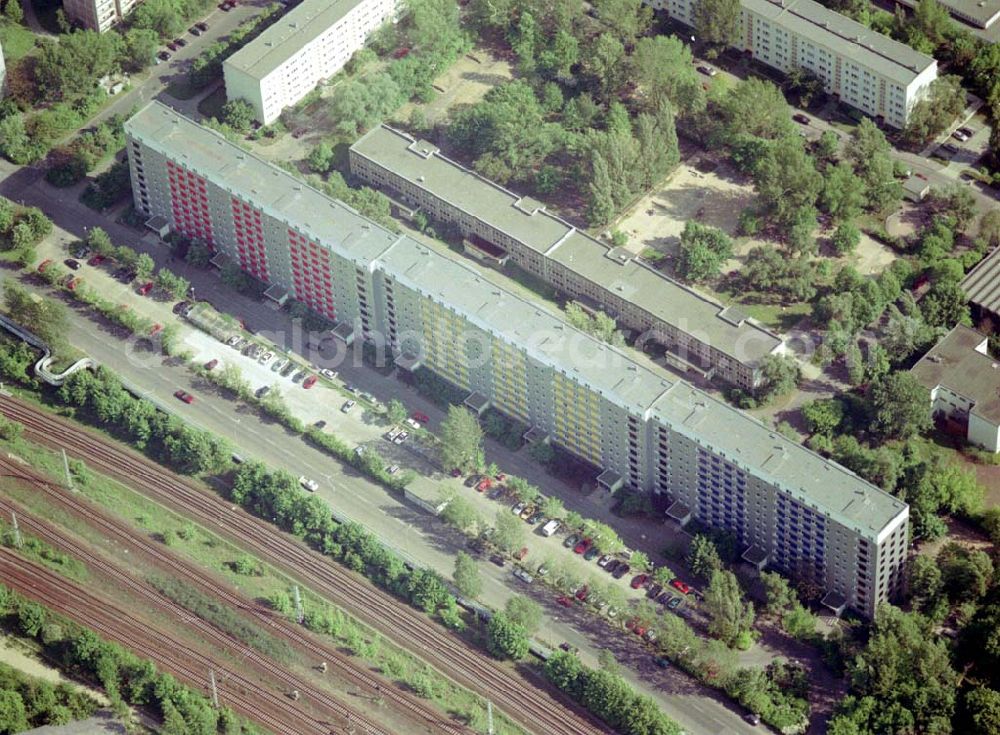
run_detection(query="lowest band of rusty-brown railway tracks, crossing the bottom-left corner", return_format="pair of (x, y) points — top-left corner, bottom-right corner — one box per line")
(0, 548), (336, 735)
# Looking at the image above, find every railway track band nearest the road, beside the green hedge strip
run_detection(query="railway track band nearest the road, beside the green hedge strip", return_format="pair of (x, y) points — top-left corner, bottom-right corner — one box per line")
(0, 398), (612, 735)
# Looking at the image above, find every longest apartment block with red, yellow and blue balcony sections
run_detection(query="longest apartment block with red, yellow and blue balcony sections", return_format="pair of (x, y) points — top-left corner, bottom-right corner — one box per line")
(125, 102), (909, 616)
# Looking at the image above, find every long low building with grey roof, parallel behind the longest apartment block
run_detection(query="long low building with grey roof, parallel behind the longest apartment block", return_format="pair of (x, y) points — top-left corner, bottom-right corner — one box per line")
(350, 125), (784, 388)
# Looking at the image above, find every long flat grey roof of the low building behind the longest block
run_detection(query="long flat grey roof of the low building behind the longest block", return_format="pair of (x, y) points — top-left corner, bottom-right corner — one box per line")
(351, 125), (781, 365)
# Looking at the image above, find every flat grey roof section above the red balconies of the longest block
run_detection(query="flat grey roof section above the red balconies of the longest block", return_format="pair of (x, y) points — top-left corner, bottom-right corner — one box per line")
(125, 101), (398, 265)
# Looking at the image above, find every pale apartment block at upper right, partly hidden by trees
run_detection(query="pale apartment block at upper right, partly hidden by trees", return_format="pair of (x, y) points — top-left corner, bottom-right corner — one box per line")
(647, 0), (937, 128)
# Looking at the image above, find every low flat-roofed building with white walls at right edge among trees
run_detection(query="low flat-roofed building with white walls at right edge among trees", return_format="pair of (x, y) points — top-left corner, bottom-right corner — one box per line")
(910, 324), (1000, 452)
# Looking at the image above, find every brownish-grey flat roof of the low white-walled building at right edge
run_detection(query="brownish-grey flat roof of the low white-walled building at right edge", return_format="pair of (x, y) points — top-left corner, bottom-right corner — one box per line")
(910, 324), (1000, 424)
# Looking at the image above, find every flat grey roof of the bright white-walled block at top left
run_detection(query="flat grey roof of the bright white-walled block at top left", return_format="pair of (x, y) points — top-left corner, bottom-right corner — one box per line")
(225, 0), (365, 80)
